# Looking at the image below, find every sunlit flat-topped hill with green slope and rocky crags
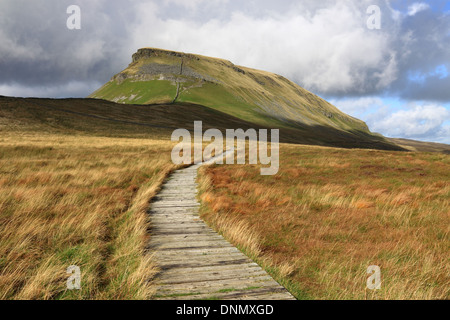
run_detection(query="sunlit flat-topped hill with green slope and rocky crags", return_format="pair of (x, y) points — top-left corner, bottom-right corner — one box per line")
(89, 48), (401, 150)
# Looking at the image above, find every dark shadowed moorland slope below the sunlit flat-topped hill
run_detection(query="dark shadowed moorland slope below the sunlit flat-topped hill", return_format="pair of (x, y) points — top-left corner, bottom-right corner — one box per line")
(0, 96), (403, 150)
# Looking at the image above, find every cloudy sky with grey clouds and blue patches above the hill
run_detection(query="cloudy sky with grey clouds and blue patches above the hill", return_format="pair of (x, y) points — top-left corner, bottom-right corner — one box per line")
(0, 0), (450, 143)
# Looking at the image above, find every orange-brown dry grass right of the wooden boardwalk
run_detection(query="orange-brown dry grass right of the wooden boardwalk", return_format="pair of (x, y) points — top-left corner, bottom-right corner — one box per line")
(200, 145), (450, 299)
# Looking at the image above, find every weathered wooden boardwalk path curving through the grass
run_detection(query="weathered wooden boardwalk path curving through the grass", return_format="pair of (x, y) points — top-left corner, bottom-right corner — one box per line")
(149, 152), (294, 300)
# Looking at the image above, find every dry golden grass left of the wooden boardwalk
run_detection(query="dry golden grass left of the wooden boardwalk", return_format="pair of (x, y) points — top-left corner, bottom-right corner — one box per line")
(0, 132), (179, 299)
